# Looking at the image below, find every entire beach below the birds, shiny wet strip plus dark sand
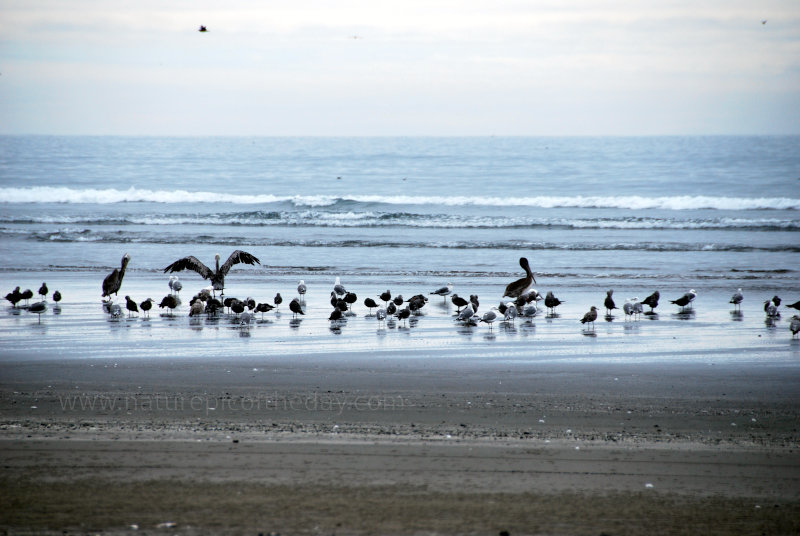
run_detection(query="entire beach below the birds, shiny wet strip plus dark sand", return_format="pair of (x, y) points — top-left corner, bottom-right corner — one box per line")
(0, 276), (800, 534)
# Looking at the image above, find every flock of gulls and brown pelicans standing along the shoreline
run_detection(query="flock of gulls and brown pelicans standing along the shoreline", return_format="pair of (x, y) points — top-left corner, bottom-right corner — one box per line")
(6, 249), (800, 338)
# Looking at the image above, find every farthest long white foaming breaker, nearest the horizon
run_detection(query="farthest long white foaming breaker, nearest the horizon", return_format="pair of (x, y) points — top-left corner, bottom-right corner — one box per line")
(0, 186), (800, 210)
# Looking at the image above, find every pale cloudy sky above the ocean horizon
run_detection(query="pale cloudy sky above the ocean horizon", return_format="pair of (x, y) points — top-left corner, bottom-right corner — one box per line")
(0, 0), (800, 136)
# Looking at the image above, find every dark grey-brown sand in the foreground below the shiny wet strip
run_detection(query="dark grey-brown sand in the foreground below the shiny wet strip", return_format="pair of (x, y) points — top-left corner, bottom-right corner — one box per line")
(0, 355), (800, 535)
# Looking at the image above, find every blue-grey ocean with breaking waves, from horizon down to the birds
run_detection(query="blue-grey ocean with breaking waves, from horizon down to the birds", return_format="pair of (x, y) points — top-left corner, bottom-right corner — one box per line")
(0, 136), (800, 364)
